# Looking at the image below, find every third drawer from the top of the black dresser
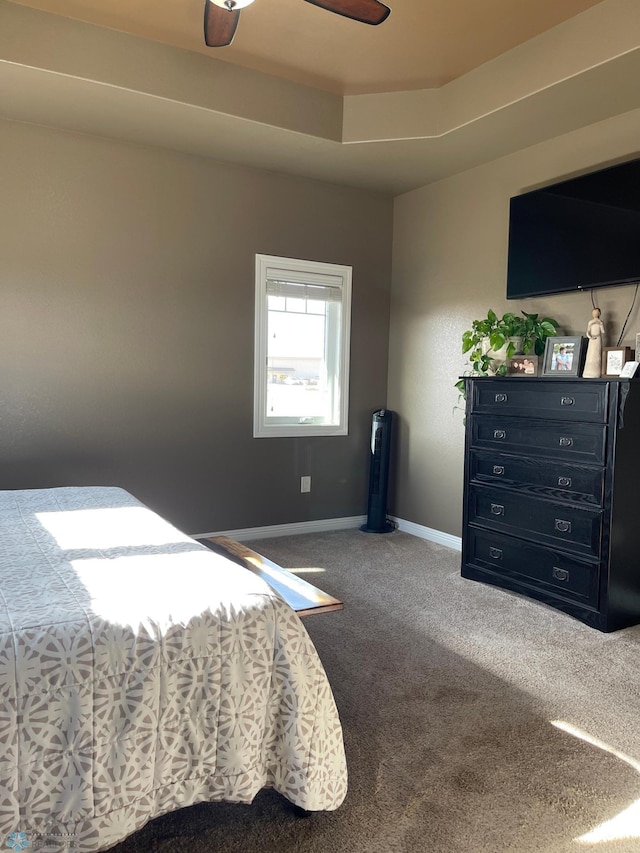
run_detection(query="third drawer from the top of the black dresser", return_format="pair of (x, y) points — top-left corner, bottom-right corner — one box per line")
(469, 450), (604, 507)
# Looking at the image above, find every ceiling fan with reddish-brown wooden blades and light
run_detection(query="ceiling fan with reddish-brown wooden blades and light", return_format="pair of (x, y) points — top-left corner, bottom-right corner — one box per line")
(204, 0), (391, 47)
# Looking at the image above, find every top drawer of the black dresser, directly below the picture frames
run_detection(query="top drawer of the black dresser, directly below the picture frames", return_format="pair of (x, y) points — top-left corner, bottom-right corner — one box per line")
(471, 378), (609, 423)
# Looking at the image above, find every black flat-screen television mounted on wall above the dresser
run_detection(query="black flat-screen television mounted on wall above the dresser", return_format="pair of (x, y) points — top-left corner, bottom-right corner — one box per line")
(507, 159), (640, 299)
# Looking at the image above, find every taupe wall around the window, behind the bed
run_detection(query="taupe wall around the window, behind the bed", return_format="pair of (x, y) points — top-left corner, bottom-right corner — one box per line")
(0, 122), (392, 533)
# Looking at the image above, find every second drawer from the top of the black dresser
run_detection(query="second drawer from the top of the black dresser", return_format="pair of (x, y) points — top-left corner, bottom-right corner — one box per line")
(468, 414), (607, 465)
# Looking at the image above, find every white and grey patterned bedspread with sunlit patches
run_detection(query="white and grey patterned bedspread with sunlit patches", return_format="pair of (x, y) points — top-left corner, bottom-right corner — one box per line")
(0, 487), (347, 853)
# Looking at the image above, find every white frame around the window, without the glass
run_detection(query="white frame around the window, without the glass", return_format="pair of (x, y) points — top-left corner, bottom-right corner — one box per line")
(253, 255), (352, 438)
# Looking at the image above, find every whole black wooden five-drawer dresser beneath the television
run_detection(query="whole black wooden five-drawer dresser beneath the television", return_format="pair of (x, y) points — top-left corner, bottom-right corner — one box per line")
(462, 377), (640, 631)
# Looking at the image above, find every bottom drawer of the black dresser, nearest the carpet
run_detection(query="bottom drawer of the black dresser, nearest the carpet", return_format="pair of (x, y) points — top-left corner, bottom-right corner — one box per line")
(463, 527), (600, 610)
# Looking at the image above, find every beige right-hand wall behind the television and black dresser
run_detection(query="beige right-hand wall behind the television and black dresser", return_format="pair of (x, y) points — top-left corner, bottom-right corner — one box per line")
(388, 105), (640, 535)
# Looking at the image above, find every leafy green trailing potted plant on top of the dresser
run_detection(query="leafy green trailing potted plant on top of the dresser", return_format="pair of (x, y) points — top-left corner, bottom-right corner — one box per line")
(456, 308), (559, 394)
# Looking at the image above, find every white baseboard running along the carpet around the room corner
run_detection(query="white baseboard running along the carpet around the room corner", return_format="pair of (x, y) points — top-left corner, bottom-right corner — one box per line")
(191, 515), (462, 551)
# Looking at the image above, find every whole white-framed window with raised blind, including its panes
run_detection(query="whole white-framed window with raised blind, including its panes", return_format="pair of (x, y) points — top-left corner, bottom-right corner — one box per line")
(253, 255), (351, 438)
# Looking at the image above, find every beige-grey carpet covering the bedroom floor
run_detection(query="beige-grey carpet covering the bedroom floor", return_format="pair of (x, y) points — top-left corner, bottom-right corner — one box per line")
(113, 530), (640, 853)
